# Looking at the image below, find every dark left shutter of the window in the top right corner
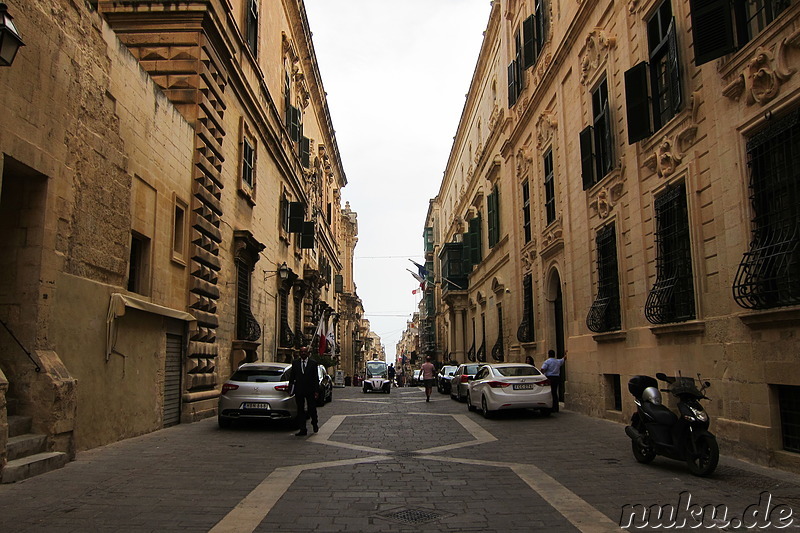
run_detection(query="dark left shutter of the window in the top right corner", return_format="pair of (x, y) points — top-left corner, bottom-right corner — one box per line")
(689, 0), (736, 66)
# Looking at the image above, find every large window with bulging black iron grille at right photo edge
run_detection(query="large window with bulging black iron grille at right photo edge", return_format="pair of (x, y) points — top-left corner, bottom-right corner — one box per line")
(733, 111), (800, 309)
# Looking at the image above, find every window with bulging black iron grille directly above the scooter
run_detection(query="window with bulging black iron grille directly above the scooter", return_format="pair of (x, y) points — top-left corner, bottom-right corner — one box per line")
(644, 183), (695, 324)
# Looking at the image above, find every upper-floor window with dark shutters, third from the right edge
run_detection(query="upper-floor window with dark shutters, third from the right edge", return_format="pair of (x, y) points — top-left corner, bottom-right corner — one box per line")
(580, 79), (614, 190)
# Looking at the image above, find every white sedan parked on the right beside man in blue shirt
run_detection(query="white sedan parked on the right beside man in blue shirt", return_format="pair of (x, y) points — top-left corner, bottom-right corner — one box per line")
(467, 363), (553, 418)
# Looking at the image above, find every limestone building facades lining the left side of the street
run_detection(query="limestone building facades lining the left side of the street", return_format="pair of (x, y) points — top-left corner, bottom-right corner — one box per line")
(0, 0), (358, 476)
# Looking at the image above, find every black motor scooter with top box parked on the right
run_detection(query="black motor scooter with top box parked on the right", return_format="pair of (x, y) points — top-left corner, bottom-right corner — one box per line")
(625, 372), (719, 476)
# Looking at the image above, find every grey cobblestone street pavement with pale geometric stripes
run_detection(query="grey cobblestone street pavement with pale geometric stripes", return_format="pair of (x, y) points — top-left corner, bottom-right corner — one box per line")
(0, 387), (800, 532)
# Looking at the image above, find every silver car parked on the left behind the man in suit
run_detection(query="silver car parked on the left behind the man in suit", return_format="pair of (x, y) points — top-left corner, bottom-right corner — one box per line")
(217, 363), (297, 428)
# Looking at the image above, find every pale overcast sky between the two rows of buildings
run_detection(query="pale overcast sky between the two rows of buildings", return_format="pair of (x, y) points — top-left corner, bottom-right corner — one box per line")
(305, 0), (491, 360)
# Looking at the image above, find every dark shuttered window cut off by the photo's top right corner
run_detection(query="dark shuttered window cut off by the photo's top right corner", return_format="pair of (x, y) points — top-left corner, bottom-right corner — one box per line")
(689, 0), (794, 65)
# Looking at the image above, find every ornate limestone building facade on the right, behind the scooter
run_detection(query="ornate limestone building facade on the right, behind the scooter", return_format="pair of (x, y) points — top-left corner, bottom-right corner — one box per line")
(428, 0), (800, 470)
